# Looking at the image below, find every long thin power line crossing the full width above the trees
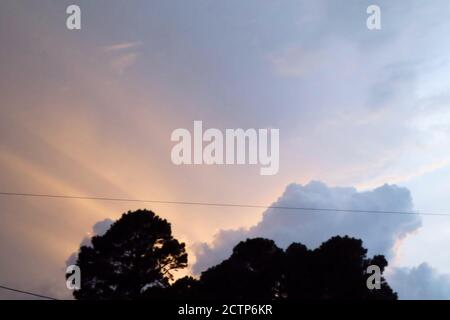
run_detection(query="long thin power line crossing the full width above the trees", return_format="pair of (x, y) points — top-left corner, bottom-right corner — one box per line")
(0, 192), (450, 217)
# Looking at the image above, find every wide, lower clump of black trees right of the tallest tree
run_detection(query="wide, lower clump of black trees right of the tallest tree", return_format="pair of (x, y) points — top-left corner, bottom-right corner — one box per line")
(197, 236), (397, 300)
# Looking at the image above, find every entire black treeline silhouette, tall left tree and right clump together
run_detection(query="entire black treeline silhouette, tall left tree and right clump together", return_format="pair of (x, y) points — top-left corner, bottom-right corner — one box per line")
(66, 210), (397, 300)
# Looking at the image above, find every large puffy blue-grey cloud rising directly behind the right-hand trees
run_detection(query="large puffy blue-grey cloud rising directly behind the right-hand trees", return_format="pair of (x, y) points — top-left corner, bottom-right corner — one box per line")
(193, 181), (421, 273)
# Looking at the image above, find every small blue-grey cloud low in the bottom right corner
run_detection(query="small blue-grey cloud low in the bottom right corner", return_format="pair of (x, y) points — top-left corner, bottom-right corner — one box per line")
(386, 263), (450, 300)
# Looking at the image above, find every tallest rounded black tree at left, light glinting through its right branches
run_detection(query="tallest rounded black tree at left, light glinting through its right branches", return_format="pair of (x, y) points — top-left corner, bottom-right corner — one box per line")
(74, 210), (187, 299)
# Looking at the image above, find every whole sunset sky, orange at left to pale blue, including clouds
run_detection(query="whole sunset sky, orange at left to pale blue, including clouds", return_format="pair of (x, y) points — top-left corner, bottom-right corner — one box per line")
(0, 0), (450, 299)
